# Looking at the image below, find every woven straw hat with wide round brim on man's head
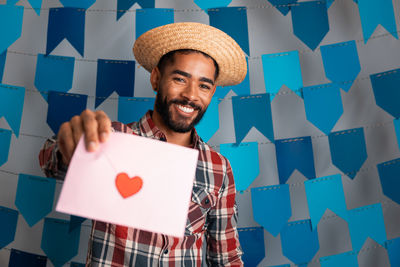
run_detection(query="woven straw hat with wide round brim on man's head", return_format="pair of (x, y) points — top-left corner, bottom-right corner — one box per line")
(133, 22), (247, 86)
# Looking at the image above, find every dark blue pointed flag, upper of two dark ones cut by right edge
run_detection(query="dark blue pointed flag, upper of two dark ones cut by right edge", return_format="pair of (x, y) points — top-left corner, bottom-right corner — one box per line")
(370, 69), (400, 118)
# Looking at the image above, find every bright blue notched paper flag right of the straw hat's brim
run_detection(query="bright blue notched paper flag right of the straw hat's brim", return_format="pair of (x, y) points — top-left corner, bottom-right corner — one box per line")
(261, 51), (303, 101)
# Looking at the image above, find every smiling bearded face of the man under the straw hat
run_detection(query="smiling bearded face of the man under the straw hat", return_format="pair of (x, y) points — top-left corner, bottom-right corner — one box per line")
(151, 52), (216, 133)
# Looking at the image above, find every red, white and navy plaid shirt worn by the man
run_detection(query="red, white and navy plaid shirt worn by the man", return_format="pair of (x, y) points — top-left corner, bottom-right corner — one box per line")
(39, 111), (243, 267)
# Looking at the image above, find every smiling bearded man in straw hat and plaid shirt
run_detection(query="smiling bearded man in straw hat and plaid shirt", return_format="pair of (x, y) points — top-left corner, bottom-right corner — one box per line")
(39, 23), (247, 266)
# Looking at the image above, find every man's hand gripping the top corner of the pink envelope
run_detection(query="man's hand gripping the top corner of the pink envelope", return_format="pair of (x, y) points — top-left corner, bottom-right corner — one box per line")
(57, 109), (111, 164)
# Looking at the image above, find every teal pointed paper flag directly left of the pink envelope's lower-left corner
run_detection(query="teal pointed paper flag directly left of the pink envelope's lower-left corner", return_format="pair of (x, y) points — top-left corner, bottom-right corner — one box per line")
(15, 174), (56, 227)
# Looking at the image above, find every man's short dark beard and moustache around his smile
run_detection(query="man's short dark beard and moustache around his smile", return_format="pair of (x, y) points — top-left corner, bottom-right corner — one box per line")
(155, 87), (207, 133)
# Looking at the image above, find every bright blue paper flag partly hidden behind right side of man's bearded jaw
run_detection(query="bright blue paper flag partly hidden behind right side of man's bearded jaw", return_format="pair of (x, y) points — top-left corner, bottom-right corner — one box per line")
(196, 97), (219, 142)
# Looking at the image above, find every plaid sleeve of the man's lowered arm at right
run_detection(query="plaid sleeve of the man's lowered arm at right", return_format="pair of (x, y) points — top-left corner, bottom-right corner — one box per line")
(206, 160), (243, 266)
